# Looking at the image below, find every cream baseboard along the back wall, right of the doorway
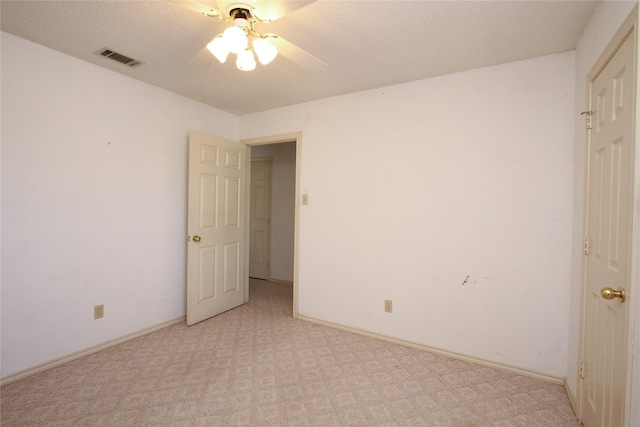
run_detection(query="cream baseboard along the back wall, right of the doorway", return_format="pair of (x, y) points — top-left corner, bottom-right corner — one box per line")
(298, 314), (566, 385)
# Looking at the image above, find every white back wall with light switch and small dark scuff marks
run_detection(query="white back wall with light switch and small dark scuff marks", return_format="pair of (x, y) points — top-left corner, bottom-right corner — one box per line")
(240, 52), (575, 376)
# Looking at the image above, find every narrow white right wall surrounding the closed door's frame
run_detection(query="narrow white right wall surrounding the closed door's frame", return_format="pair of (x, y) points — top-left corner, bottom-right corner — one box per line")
(567, 1), (640, 418)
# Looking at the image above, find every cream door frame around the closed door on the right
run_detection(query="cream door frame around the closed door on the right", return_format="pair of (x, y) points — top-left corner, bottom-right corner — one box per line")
(577, 5), (640, 426)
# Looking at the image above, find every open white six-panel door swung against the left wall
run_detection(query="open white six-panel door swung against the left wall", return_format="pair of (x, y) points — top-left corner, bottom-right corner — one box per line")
(187, 131), (248, 325)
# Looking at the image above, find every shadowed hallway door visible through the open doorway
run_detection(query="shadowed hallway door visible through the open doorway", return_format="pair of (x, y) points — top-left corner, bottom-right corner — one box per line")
(249, 159), (271, 279)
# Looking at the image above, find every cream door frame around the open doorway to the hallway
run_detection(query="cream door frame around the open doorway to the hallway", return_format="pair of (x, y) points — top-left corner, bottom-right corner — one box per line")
(240, 132), (302, 318)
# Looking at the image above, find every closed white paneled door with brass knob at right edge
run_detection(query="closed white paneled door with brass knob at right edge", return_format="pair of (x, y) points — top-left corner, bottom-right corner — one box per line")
(580, 24), (636, 427)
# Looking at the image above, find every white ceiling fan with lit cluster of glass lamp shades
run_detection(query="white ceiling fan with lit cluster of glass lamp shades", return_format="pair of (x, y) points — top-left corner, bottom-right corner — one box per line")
(179, 0), (328, 71)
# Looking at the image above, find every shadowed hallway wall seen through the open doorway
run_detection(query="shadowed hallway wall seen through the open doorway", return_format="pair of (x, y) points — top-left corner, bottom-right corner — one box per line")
(251, 142), (296, 282)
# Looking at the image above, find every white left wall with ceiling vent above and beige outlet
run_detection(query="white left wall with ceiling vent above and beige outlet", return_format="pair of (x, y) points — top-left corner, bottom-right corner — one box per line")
(2, 33), (238, 376)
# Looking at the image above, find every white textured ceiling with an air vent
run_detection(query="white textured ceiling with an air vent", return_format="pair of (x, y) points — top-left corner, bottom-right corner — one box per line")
(0, 0), (597, 115)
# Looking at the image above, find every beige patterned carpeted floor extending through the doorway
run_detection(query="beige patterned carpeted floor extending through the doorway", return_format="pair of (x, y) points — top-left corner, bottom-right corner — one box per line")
(0, 280), (580, 427)
